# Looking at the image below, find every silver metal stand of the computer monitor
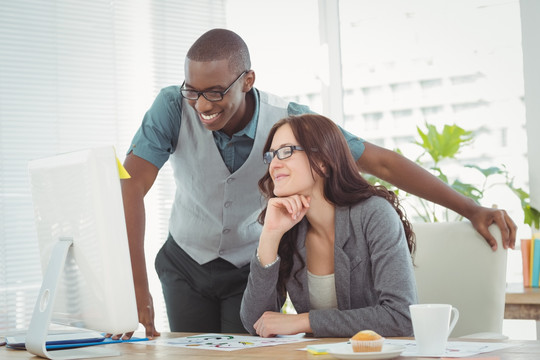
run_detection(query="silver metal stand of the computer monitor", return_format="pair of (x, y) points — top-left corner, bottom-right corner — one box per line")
(25, 238), (120, 359)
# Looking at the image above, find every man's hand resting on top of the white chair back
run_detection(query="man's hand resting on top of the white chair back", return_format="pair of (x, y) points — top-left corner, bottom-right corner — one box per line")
(468, 206), (517, 251)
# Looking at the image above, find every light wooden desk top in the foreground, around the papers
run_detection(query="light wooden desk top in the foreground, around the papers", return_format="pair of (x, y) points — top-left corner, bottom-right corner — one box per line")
(0, 333), (540, 360)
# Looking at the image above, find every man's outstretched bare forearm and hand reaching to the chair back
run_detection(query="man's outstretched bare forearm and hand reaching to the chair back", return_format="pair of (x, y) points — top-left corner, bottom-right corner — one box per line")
(356, 142), (517, 250)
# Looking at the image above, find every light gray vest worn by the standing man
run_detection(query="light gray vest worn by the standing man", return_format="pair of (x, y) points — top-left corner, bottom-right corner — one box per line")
(169, 92), (288, 267)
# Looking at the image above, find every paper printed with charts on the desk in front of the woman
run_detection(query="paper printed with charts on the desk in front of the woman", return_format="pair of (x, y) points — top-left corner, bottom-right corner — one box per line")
(138, 334), (315, 351)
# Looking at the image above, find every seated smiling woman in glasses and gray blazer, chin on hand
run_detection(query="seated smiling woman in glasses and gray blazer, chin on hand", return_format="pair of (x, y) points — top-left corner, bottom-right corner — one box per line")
(240, 114), (416, 337)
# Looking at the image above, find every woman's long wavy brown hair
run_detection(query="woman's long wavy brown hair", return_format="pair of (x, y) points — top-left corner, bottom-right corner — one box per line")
(259, 114), (415, 295)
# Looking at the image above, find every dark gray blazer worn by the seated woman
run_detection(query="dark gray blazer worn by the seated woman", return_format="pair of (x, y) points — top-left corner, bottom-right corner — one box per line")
(240, 196), (417, 337)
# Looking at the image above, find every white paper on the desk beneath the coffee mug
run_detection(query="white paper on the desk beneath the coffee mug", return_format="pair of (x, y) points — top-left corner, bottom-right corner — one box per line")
(384, 339), (515, 358)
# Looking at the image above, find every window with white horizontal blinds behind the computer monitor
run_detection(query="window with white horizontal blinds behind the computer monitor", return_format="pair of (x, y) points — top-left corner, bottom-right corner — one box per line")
(0, 0), (225, 335)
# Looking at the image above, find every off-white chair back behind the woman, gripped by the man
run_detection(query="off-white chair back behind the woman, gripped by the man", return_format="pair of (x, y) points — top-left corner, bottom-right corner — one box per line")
(413, 221), (507, 337)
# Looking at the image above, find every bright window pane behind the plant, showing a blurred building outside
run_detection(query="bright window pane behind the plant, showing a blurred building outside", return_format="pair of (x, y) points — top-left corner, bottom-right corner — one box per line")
(339, 0), (532, 238)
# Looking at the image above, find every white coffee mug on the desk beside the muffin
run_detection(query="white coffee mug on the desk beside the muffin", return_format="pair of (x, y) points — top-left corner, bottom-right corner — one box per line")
(409, 304), (459, 356)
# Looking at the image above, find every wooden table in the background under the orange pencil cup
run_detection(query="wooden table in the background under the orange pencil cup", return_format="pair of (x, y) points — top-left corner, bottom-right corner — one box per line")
(504, 284), (540, 340)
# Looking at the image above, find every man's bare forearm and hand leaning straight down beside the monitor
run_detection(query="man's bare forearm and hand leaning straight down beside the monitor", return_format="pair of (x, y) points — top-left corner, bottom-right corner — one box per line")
(122, 153), (160, 338)
